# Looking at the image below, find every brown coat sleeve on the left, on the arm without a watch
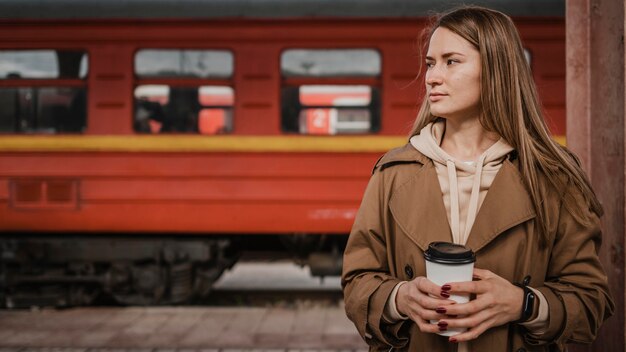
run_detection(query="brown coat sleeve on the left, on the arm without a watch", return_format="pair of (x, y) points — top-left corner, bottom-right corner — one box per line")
(341, 171), (410, 350)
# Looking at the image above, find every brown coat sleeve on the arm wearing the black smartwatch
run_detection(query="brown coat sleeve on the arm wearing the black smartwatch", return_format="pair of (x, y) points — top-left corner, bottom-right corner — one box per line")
(526, 192), (615, 350)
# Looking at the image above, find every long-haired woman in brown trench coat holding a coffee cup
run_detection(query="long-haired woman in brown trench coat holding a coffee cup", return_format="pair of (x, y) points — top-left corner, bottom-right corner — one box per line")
(342, 7), (614, 352)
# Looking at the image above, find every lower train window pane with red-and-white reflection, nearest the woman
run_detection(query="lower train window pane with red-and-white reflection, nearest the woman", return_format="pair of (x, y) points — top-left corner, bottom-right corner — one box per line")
(282, 85), (379, 135)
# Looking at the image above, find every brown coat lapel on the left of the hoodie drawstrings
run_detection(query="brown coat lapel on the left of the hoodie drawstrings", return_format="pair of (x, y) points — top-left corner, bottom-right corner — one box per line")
(389, 159), (452, 251)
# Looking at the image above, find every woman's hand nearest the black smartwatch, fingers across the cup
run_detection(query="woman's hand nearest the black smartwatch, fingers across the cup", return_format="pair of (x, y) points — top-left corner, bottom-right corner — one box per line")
(439, 269), (524, 342)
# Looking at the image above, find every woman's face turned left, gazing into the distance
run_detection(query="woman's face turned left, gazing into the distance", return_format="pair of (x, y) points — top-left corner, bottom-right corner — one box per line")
(426, 27), (481, 122)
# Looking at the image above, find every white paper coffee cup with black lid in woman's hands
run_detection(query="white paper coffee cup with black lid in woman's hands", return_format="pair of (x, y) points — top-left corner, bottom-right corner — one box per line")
(424, 242), (476, 336)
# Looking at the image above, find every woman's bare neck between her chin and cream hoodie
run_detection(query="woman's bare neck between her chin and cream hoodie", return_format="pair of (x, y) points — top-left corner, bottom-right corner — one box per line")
(441, 118), (500, 161)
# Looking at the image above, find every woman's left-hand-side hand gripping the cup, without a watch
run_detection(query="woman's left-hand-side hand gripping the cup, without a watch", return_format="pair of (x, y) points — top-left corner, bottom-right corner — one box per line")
(396, 276), (456, 332)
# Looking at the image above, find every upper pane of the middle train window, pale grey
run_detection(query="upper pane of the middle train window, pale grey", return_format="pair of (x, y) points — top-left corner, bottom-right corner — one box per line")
(135, 49), (234, 78)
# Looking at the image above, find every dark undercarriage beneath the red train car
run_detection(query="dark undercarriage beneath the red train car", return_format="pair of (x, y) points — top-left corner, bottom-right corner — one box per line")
(0, 234), (347, 308)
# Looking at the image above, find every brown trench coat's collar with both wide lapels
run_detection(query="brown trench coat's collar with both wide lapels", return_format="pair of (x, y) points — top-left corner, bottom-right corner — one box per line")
(388, 146), (535, 252)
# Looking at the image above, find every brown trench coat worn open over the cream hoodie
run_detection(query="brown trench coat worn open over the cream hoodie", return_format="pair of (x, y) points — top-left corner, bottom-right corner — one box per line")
(342, 144), (614, 352)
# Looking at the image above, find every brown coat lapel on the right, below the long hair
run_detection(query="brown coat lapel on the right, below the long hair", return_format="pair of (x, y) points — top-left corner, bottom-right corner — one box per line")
(466, 160), (535, 252)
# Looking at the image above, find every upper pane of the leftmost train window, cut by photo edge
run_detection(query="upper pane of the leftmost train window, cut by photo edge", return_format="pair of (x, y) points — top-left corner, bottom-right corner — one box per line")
(0, 50), (88, 79)
